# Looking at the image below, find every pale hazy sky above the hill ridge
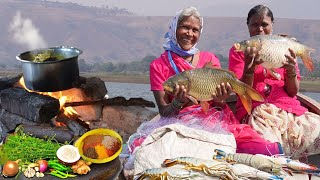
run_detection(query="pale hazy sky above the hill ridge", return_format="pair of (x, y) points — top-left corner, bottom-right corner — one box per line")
(49, 0), (320, 19)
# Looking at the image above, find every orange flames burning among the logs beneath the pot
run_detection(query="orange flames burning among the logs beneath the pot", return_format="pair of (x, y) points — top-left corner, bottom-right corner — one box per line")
(15, 77), (84, 118)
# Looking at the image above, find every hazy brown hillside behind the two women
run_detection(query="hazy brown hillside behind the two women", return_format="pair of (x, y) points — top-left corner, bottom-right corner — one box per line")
(0, 0), (320, 69)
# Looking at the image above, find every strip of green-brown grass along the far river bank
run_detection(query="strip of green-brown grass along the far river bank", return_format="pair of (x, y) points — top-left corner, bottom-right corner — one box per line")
(0, 70), (320, 92)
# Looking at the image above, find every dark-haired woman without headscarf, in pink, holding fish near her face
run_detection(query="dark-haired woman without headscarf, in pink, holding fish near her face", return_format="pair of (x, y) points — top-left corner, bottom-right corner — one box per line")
(229, 5), (320, 161)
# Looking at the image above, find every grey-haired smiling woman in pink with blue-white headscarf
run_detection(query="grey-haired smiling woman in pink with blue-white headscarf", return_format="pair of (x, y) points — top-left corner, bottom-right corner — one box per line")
(129, 7), (282, 155)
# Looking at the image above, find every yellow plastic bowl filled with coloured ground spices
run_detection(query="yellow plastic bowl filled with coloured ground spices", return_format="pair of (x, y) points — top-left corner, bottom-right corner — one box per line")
(74, 128), (122, 164)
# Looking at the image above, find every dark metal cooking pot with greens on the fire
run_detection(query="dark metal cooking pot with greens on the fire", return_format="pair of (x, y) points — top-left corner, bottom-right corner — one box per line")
(16, 46), (82, 92)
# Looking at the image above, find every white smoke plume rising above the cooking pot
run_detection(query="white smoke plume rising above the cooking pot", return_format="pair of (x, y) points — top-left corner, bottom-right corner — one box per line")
(9, 11), (47, 49)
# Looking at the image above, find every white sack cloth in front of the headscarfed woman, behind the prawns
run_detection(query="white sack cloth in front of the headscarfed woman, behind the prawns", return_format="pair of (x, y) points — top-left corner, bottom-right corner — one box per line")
(134, 124), (236, 174)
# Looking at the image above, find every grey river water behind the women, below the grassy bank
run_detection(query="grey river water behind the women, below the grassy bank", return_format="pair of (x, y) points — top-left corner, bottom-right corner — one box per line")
(105, 82), (320, 106)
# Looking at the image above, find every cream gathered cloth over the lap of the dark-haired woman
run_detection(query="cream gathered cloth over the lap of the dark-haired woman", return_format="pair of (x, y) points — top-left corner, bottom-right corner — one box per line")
(248, 103), (320, 159)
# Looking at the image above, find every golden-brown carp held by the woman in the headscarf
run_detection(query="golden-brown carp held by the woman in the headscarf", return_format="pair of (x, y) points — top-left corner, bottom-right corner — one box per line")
(162, 66), (264, 114)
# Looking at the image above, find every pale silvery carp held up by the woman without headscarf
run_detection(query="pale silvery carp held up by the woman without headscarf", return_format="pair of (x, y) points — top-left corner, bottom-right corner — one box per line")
(233, 35), (315, 79)
